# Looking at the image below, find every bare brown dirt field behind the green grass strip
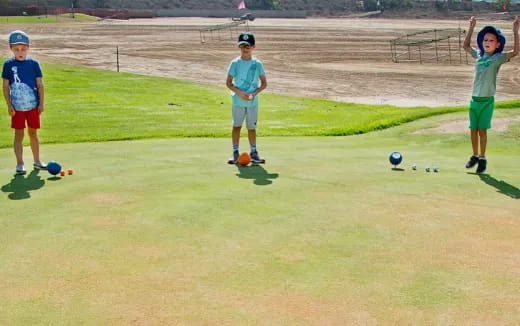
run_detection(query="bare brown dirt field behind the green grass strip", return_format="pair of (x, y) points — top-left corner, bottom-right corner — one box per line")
(0, 18), (520, 106)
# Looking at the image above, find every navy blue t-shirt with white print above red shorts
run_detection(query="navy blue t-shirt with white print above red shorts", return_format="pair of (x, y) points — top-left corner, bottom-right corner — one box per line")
(2, 57), (43, 111)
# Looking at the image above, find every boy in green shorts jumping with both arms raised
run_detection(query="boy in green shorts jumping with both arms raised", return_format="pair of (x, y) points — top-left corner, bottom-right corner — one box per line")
(463, 17), (520, 174)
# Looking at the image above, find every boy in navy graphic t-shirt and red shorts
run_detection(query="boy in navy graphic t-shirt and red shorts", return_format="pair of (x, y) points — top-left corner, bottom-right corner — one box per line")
(2, 31), (47, 174)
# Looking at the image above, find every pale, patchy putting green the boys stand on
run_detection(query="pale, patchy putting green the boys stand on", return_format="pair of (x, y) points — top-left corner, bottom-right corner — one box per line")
(0, 109), (520, 326)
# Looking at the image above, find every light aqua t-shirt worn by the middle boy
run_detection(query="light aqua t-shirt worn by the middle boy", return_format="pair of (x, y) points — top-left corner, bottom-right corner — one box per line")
(228, 57), (265, 107)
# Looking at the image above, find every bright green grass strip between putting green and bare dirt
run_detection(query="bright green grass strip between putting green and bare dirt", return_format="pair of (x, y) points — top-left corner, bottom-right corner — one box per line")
(0, 60), (520, 147)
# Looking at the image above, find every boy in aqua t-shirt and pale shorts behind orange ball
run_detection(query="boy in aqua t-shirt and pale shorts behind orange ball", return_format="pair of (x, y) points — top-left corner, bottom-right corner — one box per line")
(226, 33), (267, 164)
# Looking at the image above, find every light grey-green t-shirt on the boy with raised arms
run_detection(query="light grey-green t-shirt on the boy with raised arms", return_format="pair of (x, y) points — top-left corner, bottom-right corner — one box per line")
(471, 48), (508, 97)
